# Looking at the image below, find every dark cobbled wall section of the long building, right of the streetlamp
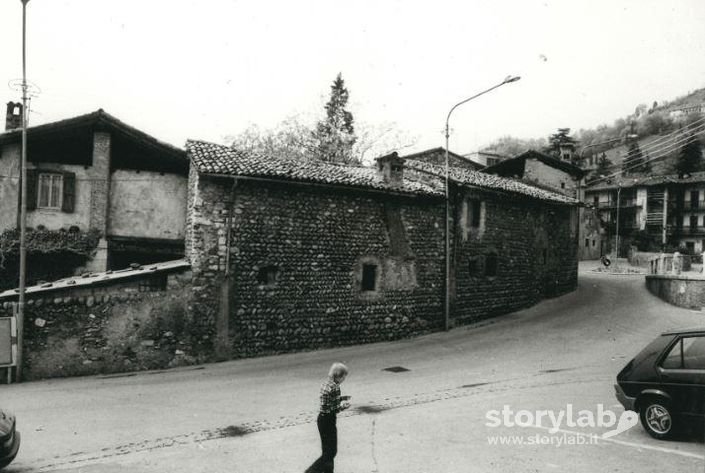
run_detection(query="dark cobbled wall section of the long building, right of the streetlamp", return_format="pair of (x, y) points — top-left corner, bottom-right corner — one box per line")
(452, 191), (578, 325)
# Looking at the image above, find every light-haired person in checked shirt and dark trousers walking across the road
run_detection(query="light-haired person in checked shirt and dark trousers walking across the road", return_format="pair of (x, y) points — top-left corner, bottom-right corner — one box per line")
(306, 363), (350, 473)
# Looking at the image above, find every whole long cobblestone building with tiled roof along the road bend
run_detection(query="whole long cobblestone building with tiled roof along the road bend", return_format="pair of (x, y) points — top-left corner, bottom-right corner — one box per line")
(186, 141), (578, 358)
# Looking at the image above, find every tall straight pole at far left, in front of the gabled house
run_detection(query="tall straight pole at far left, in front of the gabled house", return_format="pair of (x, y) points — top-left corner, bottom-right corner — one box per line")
(15, 0), (29, 381)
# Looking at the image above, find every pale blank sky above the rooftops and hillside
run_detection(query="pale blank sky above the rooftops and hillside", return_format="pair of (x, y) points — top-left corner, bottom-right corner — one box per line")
(0, 0), (705, 153)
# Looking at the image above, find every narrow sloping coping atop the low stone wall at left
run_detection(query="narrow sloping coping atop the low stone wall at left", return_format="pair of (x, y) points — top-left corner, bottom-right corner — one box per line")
(0, 259), (191, 300)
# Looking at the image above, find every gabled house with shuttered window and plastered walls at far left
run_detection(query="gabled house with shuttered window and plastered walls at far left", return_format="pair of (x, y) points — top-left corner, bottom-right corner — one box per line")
(0, 102), (188, 277)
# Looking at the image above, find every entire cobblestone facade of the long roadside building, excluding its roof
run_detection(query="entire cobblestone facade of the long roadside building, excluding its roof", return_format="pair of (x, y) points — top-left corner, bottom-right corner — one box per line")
(187, 176), (578, 356)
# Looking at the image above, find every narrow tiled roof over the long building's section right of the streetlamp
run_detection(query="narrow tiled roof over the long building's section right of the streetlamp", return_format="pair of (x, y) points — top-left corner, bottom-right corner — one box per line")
(405, 160), (579, 205)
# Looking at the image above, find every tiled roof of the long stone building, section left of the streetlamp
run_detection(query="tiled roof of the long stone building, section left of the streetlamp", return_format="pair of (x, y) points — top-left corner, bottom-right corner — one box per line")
(186, 140), (444, 196)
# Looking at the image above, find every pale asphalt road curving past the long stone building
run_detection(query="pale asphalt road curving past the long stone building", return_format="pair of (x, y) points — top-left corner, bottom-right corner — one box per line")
(0, 263), (705, 473)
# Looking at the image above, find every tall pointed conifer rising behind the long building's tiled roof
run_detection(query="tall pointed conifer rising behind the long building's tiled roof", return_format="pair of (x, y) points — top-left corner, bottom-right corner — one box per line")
(312, 74), (359, 163)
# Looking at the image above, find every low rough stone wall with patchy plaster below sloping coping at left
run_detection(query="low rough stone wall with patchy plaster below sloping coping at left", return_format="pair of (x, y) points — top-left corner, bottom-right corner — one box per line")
(0, 270), (195, 380)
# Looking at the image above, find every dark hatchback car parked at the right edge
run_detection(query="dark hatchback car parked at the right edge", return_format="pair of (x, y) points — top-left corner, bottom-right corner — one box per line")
(614, 328), (705, 439)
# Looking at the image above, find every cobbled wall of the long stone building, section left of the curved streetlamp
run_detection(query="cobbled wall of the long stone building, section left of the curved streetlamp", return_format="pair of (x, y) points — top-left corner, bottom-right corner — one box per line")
(189, 176), (444, 356)
